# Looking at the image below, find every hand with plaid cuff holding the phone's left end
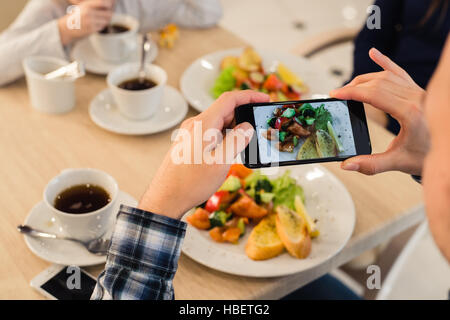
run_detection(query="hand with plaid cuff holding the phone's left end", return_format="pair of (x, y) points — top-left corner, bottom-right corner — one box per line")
(139, 91), (269, 219)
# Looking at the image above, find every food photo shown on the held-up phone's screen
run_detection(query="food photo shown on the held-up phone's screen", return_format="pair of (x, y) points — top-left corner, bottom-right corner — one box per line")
(253, 101), (357, 164)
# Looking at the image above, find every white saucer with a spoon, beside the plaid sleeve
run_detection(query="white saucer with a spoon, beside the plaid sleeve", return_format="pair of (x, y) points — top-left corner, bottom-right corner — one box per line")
(24, 191), (137, 267)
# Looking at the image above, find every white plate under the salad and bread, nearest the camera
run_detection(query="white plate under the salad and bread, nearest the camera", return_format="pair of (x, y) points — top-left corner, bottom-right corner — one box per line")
(182, 165), (356, 277)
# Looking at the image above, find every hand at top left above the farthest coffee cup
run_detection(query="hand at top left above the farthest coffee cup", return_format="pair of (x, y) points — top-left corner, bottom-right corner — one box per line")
(58, 0), (115, 45)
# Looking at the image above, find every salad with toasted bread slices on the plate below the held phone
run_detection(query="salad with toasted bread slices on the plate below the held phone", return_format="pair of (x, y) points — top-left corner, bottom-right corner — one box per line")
(186, 164), (319, 260)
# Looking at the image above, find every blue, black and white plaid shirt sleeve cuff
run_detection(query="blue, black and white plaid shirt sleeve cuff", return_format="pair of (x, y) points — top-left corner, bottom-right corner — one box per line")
(91, 205), (186, 300)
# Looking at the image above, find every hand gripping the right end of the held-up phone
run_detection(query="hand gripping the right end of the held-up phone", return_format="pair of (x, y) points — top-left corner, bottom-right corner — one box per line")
(330, 48), (430, 175)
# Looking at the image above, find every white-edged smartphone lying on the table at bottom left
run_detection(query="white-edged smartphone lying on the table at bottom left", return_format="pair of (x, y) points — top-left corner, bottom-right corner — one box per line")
(30, 264), (97, 300)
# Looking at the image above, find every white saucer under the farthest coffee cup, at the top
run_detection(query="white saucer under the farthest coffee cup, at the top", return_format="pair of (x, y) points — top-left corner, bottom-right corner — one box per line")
(71, 37), (158, 75)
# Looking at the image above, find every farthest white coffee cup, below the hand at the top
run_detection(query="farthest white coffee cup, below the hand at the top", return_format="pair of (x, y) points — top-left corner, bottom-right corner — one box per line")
(89, 14), (139, 62)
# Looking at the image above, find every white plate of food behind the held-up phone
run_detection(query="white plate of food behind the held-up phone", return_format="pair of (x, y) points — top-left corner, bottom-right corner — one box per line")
(180, 48), (336, 112)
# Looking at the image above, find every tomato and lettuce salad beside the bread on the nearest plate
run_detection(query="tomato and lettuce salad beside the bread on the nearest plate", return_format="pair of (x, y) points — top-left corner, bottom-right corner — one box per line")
(187, 164), (304, 243)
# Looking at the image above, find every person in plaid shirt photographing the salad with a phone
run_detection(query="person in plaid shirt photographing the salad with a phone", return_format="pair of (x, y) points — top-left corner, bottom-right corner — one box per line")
(91, 36), (450, 299)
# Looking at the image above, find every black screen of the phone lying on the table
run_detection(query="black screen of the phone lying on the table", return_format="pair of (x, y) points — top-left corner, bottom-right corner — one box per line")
(41, 267), (97, 300)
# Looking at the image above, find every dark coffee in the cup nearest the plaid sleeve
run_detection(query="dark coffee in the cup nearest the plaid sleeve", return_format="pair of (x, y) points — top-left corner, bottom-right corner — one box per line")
(55, 184), (111, 214)
